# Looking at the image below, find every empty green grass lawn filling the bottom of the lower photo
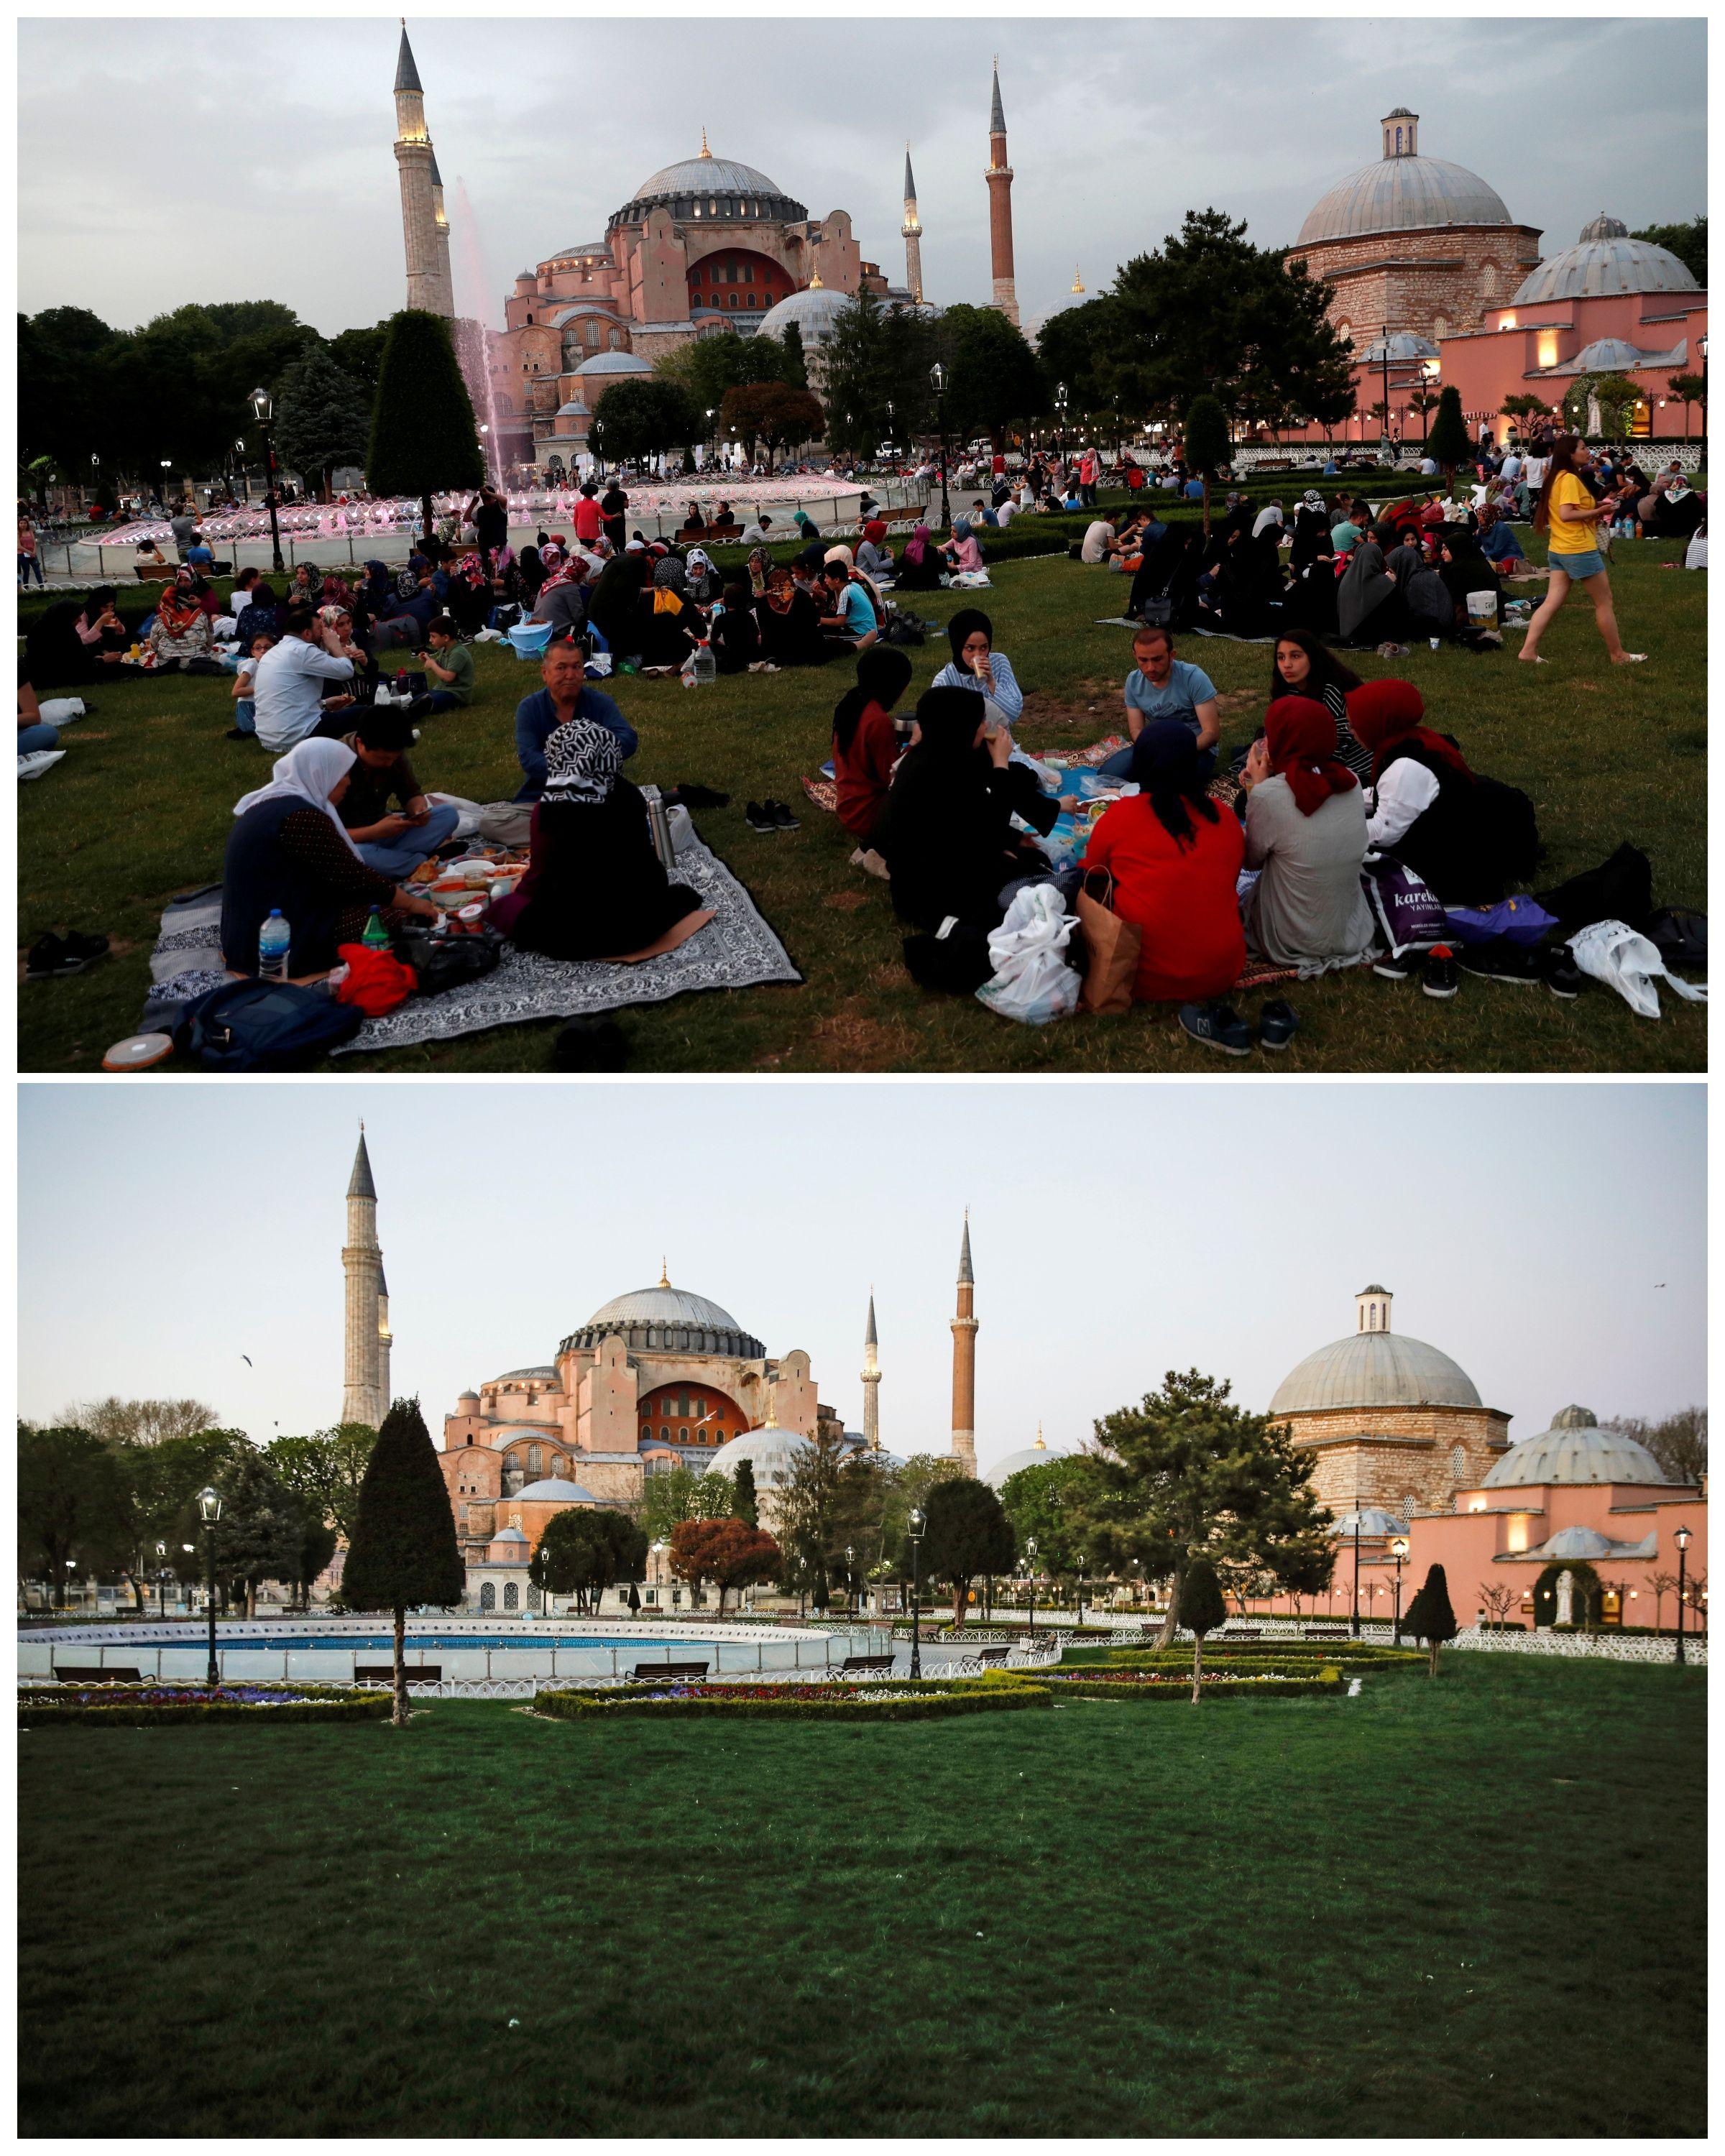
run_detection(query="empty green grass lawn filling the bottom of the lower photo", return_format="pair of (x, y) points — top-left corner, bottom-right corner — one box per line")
(19, 1654), (1706, 2137)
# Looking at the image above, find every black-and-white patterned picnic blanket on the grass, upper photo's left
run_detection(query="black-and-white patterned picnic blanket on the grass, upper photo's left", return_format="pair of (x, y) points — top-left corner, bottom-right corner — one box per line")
(149, 834), (802, 1054)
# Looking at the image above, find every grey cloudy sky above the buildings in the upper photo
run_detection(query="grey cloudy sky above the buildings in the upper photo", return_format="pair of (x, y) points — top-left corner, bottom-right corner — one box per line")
(19, 11), (1706, 334)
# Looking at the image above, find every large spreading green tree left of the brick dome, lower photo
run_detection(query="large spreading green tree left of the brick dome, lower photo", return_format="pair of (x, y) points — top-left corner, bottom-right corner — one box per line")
(1089, 1369), (1330, 1643)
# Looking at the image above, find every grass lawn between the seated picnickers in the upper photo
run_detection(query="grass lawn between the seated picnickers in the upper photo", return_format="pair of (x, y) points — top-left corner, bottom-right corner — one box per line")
(19, 541), (1706, 1072)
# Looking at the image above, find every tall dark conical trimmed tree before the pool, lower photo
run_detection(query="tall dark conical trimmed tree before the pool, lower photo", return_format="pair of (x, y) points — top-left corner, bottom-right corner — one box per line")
(341, 1399), (468, 1725)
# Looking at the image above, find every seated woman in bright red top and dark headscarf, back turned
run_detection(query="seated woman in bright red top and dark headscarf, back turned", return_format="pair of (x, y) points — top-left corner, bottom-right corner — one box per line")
(1085, 718), (1246, 1003)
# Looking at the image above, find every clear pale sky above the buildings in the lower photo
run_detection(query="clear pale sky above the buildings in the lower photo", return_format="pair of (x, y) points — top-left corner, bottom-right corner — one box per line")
(19, 1078), (1706, 1464)
